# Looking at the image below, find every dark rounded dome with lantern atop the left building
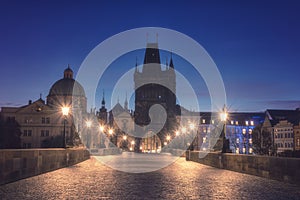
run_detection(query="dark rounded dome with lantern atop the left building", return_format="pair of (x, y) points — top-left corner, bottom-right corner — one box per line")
(48, 67), (85, 97)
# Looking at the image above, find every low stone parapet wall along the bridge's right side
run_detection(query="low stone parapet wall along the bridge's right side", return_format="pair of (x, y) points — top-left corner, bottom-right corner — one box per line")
(186, 151), (300, 185)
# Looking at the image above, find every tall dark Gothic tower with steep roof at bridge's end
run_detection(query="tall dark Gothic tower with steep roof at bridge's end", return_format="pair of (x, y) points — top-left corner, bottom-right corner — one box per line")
(134, 43), (176, 150)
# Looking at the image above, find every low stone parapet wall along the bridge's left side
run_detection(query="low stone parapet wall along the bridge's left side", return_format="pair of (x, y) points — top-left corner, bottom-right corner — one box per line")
(0, 148), (90, 185)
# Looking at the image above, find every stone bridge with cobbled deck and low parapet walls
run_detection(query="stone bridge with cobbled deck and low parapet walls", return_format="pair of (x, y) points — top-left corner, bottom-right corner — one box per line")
(0, 149), (300, 199)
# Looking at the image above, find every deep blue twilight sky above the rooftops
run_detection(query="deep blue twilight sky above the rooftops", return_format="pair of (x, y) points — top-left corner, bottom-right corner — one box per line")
(0, 0), (300, 111)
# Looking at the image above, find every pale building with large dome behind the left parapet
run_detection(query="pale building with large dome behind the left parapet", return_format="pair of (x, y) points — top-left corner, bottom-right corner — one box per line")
(0, 67), (86, 148)
